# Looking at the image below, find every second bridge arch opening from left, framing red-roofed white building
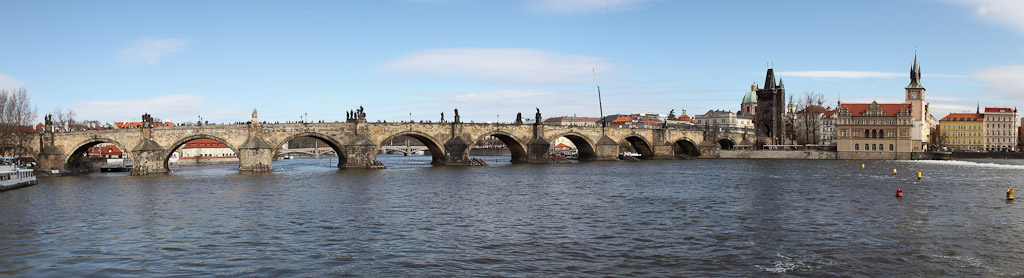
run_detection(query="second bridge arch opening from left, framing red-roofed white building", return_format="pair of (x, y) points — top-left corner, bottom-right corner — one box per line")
(164, 135), (239, 171)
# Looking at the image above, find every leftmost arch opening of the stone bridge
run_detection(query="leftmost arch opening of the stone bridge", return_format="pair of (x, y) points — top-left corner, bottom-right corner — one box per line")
(65, 140), (134, 174)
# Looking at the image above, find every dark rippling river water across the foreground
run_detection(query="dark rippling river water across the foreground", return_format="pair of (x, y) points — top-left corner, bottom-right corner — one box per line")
(0, 156), (1024, 277)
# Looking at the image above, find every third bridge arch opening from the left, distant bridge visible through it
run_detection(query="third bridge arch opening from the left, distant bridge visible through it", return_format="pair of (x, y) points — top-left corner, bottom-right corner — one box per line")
(273, 133), (348, 168)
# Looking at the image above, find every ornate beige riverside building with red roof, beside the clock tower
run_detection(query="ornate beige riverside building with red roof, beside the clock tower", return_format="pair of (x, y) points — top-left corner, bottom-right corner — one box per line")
(836, 102), (913, 159)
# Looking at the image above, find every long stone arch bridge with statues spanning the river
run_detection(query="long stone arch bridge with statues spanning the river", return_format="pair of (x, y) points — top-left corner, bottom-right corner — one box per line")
(29, 108), (757, 175)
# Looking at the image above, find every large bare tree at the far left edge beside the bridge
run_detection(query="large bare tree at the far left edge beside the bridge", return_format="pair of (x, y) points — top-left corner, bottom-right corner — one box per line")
(0, 88), (36, 156)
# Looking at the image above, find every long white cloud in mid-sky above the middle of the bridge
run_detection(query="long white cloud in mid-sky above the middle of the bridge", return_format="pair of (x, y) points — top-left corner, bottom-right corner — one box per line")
(383, 48), (615, 83)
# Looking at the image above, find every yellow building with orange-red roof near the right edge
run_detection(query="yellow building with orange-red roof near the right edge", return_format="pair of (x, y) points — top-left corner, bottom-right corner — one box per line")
(939, 113), (985, 151)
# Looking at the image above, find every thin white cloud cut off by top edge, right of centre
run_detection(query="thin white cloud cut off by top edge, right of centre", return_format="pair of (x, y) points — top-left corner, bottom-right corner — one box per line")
(527, 0), (651, 14)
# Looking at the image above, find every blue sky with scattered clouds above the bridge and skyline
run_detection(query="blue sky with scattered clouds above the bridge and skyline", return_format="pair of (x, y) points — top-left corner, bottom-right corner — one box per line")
(0, 0), (1024, 122)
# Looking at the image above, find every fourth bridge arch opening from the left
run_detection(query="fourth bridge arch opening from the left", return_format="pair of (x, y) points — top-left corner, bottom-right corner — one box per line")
(377, 132), (446, 168)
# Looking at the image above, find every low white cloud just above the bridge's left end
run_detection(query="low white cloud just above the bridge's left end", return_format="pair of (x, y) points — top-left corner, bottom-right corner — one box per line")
(71, 94), (207, 122)
